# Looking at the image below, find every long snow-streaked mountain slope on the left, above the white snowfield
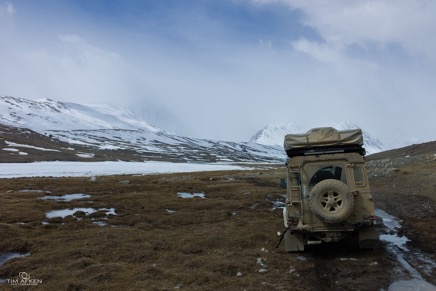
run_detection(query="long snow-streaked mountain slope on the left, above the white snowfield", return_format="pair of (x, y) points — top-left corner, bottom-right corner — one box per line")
(0, 96), (286, 162)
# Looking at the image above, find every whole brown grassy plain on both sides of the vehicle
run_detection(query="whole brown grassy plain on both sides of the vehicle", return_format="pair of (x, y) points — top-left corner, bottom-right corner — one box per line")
(0, 162), (436, 290)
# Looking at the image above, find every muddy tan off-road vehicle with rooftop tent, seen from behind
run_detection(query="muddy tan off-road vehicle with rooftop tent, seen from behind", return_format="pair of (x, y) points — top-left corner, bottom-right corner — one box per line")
(283, 127), (378, 251)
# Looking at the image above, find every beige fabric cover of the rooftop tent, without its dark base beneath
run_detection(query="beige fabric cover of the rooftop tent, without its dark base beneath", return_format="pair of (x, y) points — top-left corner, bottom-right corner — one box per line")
(284, 127), (363, 151)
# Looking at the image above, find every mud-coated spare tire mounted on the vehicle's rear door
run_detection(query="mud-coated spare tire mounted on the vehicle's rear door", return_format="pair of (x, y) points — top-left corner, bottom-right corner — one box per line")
(309, 179), (354, 223)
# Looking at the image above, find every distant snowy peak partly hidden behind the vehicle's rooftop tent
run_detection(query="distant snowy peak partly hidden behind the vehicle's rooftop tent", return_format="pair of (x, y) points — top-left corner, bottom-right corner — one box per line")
(250, 121), (385, 154)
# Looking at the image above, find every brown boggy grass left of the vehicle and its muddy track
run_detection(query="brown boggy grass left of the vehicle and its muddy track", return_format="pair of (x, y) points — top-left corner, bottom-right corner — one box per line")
(0, 171), (298, 290)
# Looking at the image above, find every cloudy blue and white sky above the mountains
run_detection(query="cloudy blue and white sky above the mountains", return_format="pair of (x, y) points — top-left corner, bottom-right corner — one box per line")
(0, 0), (436, 141)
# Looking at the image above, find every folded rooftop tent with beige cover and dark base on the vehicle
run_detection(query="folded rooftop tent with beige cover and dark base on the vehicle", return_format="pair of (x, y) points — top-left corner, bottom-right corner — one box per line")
(284, 127), (364, 157)
